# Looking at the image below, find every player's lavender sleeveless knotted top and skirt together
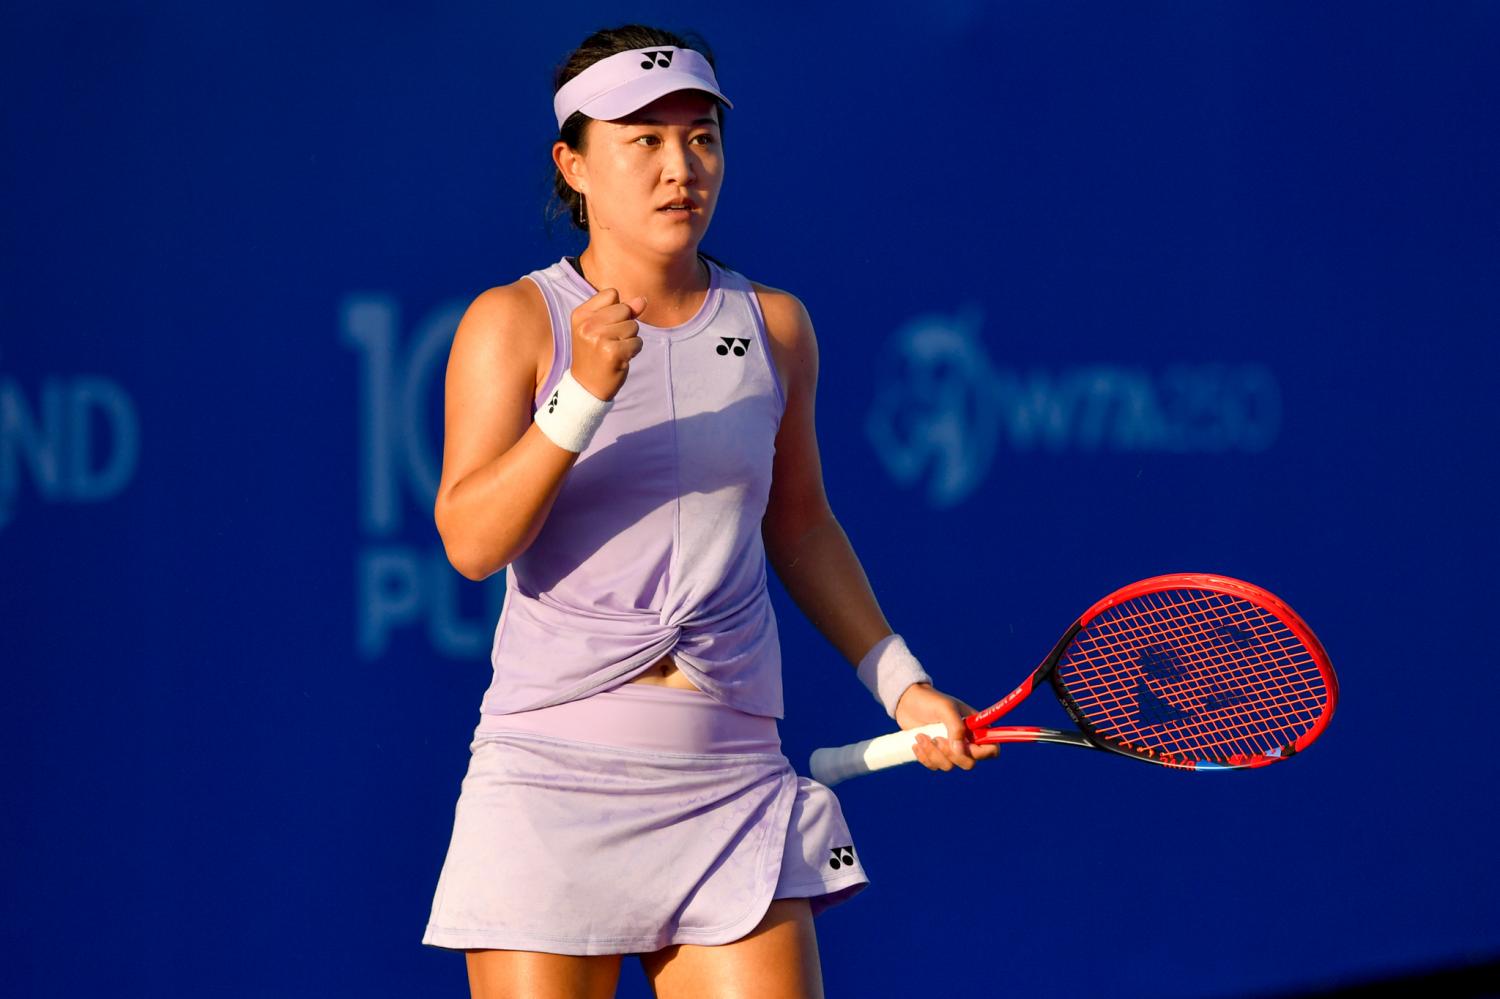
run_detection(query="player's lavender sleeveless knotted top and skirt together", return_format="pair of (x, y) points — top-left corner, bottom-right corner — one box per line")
(423, 258), (869, 954)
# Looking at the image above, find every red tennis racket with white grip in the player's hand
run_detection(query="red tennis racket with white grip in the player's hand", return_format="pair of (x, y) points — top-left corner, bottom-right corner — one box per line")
(810, 573), (1338, 785)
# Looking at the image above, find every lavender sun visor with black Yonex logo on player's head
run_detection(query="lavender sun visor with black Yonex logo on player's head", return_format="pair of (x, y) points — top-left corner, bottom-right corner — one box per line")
(552, 45), (735, 129)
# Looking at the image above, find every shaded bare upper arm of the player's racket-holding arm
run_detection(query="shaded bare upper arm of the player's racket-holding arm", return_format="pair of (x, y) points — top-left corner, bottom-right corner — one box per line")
(752, 282), (833, 560)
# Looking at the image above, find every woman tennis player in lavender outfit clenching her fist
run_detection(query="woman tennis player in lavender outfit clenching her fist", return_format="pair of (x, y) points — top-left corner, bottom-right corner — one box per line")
(423, 26), (995, 999)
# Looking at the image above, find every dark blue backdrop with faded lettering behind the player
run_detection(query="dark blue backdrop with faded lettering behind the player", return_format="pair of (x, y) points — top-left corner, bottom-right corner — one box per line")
(0, 0), (1500, 998)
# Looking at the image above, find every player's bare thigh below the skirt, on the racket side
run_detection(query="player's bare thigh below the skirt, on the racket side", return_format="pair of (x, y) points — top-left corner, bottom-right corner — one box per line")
(641, 899), (824, 999)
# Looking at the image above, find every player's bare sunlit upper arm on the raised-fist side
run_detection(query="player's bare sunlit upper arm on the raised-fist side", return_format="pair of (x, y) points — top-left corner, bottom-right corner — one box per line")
(437, 278), (552, 533)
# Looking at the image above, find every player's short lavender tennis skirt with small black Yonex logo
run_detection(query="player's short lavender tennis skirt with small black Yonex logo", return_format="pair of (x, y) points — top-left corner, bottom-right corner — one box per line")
(422, 683), (869, 954)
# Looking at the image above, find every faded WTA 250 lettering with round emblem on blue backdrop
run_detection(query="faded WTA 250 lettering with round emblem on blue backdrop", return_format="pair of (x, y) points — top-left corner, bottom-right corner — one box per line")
(866, 309), (1281, 507)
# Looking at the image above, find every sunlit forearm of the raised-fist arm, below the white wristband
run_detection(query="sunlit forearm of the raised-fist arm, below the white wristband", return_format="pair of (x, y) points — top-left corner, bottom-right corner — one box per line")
(434, 425), (578, 581)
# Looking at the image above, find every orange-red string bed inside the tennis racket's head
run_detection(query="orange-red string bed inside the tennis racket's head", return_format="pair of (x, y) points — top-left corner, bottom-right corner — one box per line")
(1058, 590), (1328, 764)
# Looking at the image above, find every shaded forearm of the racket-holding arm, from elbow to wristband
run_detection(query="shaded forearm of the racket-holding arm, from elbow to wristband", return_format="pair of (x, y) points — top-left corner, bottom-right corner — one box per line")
(767, 515), (891, 663)
